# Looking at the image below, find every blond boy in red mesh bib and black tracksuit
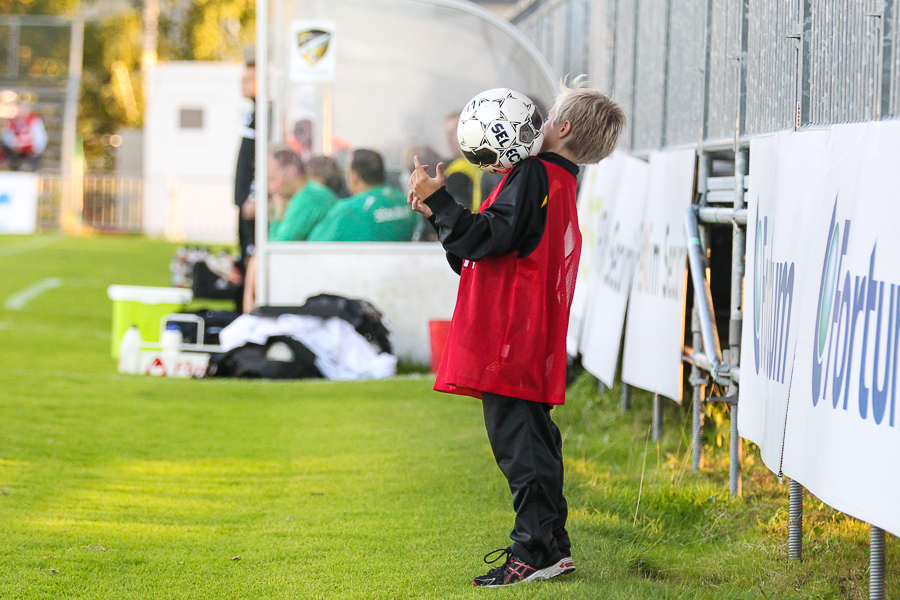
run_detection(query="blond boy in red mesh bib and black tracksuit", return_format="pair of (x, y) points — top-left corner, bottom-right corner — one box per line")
(407, 77), (625, 587)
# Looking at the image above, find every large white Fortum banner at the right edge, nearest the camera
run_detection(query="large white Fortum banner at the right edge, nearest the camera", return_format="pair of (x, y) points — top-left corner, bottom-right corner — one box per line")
(780, 122), (900, 535)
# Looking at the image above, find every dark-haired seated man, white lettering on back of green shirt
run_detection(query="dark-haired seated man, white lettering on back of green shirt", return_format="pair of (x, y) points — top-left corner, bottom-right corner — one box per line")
(307, 149), (419, 242)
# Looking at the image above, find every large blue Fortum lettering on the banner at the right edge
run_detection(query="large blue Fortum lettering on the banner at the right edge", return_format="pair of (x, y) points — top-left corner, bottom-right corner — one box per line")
(812, 198), (900, 427)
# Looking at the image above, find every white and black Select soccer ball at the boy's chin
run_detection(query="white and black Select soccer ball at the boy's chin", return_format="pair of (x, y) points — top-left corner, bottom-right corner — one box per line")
(456, 88), (544, 173)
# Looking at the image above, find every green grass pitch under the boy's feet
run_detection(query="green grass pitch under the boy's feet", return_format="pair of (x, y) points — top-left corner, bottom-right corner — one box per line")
(0, 236), (900, 600)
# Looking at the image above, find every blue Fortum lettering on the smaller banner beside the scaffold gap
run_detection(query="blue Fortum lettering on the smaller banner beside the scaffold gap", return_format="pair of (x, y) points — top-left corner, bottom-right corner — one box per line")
(753, 214), (794, 383)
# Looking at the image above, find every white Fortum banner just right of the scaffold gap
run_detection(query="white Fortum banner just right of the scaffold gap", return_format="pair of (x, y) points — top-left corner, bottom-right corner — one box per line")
(738, 131), (829, 473)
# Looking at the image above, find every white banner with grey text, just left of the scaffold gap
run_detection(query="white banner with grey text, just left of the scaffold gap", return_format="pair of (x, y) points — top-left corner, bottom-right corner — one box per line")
(622, 149), (696, 402)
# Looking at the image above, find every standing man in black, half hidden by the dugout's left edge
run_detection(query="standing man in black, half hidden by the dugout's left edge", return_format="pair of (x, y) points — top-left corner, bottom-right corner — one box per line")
(234, 59), (256, 312)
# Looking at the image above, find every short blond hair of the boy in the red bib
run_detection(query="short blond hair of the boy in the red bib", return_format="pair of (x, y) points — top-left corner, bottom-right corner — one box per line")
(554, 75), (625, 165)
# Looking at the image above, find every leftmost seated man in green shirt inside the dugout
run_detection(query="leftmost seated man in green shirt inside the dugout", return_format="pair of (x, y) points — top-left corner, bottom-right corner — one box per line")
(269, 148), (337, 242)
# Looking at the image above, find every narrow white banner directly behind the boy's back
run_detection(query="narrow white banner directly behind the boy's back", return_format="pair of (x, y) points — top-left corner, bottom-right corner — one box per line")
(566, 157), (625, 356)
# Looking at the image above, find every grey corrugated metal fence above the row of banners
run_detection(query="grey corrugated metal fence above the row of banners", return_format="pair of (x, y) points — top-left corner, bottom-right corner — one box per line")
(513, 0), (900, 153)
